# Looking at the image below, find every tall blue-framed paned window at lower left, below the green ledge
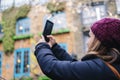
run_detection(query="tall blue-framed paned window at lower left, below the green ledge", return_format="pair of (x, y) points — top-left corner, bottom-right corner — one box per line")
(14, 48), (30, 77)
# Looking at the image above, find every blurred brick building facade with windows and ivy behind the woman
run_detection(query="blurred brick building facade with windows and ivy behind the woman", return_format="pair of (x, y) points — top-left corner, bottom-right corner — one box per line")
(0, 0), (120, 80)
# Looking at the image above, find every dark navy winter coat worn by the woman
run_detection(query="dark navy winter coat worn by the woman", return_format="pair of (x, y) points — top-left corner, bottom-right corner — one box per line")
(35, 43), (120, 80)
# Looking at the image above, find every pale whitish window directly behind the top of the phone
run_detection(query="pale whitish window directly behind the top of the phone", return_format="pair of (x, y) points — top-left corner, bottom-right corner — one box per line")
(44, 12), (67, 30)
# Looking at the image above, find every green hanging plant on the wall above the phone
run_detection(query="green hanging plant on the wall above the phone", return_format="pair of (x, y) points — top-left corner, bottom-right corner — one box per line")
(47, 2), (65, 13)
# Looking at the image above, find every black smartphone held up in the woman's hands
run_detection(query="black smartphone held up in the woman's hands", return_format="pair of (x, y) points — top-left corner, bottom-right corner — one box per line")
(43, 20), (54, 42)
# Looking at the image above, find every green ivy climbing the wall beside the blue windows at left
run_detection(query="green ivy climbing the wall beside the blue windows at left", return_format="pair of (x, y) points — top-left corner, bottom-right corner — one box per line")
(2, 5), (30, 54)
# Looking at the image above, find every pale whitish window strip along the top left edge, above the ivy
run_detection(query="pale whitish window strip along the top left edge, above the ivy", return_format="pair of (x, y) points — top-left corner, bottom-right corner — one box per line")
(0, 0), (49, 11)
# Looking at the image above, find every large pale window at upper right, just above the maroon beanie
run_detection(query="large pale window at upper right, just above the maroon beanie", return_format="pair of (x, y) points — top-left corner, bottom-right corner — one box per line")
(81, 2), (107, 27)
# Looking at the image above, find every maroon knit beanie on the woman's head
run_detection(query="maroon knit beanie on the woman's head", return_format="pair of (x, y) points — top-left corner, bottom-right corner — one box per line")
(91, 18), (120, 49)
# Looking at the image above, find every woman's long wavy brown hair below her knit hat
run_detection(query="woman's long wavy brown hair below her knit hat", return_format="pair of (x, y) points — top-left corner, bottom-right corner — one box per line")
(88, 37), (120, 64)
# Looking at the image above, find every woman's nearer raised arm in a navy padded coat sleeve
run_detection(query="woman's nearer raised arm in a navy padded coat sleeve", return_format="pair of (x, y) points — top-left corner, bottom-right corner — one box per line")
(35, 43), (105, 80)
